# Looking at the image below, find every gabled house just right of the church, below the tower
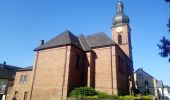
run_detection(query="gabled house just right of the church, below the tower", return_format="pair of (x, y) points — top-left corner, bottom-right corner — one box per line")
(134, 68), (158, 97)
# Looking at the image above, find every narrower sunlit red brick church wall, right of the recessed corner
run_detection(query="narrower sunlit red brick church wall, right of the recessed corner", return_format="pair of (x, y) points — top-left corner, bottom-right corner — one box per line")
(93, 47), (112, 94)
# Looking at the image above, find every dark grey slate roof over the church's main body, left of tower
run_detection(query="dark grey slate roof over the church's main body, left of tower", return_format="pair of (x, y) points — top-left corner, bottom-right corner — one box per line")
(34, 30), (115, 51)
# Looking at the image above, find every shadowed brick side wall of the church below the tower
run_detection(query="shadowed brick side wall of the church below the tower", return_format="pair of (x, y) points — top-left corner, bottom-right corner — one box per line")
(115, 47), (133, 95)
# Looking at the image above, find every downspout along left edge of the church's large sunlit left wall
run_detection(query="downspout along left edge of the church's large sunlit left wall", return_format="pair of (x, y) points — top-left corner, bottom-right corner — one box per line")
(30, 51), (39, 100)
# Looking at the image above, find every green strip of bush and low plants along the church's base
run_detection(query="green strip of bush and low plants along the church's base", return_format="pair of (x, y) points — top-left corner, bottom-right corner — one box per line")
(69, 87), (153, 100)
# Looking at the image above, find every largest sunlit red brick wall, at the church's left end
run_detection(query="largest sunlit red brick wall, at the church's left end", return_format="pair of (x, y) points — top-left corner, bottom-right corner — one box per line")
(32, 46), (70, 100)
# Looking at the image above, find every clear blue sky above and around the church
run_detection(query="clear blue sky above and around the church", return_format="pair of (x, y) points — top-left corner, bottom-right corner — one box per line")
(0, 0), (170, 85)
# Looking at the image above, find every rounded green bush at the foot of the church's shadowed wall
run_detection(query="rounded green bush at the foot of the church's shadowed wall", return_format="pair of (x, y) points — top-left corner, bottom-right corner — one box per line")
(70, 87), (96, 97)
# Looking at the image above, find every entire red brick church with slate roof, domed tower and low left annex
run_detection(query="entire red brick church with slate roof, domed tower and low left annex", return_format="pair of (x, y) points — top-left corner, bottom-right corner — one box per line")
(7, 1), (133, 100)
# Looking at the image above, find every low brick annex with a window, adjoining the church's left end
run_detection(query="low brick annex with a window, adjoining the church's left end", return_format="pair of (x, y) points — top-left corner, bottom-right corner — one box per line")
(7, 66), (33, 100)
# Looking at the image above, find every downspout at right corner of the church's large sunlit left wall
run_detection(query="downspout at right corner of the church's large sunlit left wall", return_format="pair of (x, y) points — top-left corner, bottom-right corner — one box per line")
(61, 46), (67, 100)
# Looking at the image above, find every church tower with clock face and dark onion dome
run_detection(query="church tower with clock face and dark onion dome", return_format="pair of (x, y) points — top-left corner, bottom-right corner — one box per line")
(112, 0), (132, 60)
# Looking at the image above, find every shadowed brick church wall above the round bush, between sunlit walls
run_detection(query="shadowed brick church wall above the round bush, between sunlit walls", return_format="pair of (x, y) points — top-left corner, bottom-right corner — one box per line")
(68, 46), (87, 90)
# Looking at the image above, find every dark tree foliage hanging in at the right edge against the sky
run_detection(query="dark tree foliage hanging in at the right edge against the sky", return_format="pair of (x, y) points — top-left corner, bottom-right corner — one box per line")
(158, 0), (170, 62)
